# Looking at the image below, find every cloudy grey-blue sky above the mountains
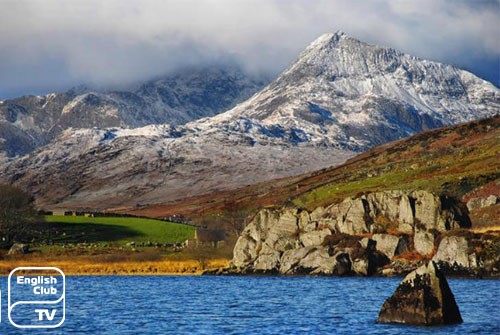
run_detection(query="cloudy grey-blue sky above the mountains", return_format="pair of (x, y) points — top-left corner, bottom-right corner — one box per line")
(0, 0), (500, 99)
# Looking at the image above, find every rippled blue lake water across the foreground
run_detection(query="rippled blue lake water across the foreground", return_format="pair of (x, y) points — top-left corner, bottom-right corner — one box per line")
(0, 276), (500, 335)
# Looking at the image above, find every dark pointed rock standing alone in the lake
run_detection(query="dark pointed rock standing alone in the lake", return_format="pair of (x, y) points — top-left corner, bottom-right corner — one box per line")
(377, 261), (462, 326)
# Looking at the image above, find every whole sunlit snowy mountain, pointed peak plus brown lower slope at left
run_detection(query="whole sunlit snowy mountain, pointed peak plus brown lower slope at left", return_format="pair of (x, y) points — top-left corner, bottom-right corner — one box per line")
(0, 32), (500, 208)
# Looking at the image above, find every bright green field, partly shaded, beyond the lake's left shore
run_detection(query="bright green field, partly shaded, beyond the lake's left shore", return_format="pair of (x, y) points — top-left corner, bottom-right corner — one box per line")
(45, 215), (195, 245)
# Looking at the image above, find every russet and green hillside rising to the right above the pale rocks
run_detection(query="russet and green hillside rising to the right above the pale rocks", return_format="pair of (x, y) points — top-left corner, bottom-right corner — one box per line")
(132, 116), (500, 226)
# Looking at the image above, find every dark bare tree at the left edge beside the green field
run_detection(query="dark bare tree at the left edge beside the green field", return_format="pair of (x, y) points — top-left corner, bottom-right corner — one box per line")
(0, 184), (42, 248)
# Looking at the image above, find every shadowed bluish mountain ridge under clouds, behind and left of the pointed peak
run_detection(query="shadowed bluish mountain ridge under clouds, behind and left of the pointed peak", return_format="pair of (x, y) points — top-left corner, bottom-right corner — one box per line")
(0, 65), (268, 160)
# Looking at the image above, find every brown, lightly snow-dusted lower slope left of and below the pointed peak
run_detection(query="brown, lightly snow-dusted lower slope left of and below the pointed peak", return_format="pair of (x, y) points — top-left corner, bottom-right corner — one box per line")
(0, 125), (350, 209)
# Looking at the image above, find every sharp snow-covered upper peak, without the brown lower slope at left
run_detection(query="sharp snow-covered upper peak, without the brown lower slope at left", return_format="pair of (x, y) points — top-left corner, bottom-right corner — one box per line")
(207, 32), (500, 150)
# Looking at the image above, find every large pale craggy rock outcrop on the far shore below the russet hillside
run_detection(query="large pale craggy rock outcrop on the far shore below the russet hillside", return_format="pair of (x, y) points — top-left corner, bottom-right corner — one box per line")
(232, 191), (470, 276)
